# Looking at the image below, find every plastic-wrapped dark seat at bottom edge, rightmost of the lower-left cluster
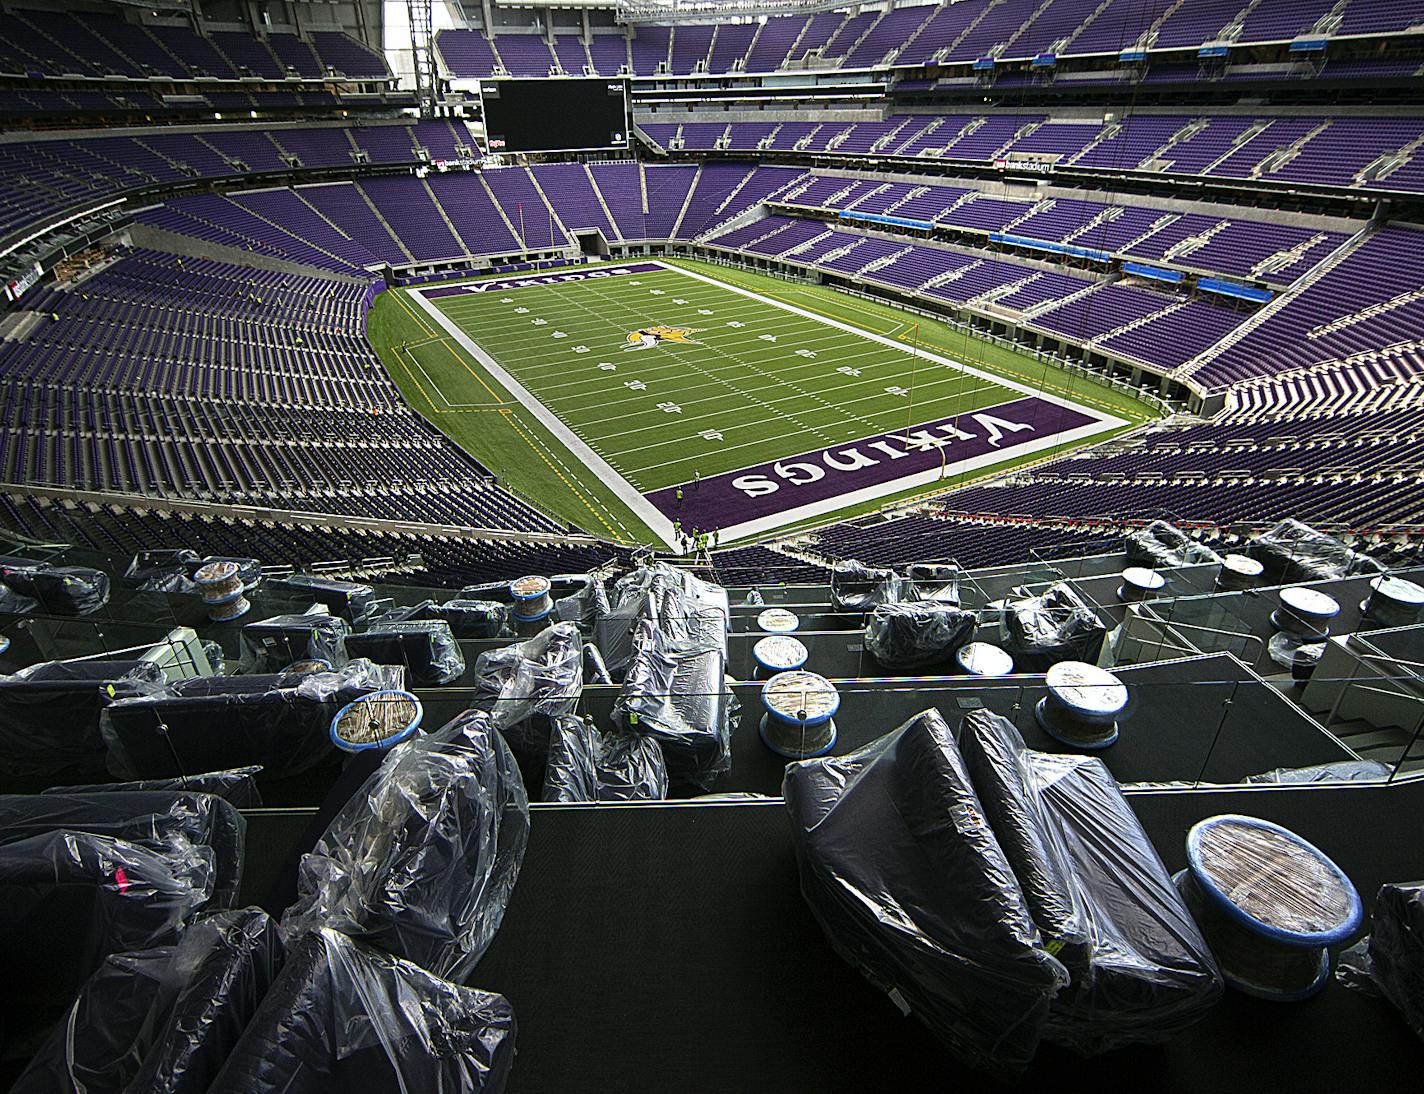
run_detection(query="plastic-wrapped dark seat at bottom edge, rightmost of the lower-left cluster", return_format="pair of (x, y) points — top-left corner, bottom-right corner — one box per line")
(208, 930), (515, 1094)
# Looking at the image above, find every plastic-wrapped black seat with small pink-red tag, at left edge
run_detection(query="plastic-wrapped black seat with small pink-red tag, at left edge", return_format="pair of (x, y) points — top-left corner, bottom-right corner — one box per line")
(0, 829), (212, 1058)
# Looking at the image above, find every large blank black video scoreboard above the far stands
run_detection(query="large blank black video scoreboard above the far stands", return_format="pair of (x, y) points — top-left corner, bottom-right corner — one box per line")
(480, 78), (629, 152)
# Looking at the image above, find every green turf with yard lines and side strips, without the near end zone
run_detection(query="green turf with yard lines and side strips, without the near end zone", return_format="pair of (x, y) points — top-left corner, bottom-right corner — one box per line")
(370, 262), (1151, 540)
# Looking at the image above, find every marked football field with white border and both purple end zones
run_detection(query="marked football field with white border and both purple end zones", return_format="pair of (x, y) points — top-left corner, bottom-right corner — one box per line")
(373, 259), (1129, 541)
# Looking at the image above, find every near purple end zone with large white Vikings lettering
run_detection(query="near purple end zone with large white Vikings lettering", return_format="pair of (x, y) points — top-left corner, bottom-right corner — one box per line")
(646, 396), (1105, 531)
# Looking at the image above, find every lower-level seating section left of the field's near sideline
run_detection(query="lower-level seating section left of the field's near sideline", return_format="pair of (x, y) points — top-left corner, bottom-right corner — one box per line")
(0, 251), (557, 530)
